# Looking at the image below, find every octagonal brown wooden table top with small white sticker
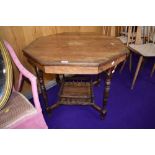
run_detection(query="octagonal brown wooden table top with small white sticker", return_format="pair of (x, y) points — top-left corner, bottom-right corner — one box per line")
(23, 33), (129, 74)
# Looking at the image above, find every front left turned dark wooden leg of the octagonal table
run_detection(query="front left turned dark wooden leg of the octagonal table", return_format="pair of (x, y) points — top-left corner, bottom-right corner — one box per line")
(35, 67), (48, 110)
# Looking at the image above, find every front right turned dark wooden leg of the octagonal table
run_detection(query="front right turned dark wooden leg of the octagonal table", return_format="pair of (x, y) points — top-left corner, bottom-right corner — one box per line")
(101, 68), (114, 118)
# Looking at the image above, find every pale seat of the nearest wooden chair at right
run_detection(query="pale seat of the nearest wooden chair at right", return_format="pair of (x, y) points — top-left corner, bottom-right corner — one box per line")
(129, 43), (155, 57)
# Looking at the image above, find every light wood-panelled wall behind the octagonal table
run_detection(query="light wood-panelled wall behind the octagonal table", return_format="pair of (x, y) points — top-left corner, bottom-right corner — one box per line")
(0, 26), (120, 92)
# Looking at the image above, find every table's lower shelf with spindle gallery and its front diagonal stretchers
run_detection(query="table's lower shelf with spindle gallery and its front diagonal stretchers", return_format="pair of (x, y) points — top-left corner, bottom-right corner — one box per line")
(47, 78), (107, 119)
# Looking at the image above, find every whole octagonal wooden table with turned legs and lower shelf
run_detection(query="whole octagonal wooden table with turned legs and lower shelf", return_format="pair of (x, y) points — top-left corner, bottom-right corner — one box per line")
(23, 33), (129, 118)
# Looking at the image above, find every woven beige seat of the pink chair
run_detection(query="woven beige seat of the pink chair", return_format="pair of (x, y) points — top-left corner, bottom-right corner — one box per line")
(0, 92), (37, 128)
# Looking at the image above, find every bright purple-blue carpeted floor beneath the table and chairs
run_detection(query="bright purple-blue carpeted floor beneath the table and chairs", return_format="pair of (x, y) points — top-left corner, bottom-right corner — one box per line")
(34, 55), (155, 129)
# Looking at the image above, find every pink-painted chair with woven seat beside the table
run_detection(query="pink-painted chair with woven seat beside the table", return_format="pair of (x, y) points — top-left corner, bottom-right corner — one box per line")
(0, 41), (47, 128)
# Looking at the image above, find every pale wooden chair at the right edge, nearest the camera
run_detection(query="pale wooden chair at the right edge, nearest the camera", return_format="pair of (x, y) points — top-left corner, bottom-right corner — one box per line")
(128, 26), (155, 89)
